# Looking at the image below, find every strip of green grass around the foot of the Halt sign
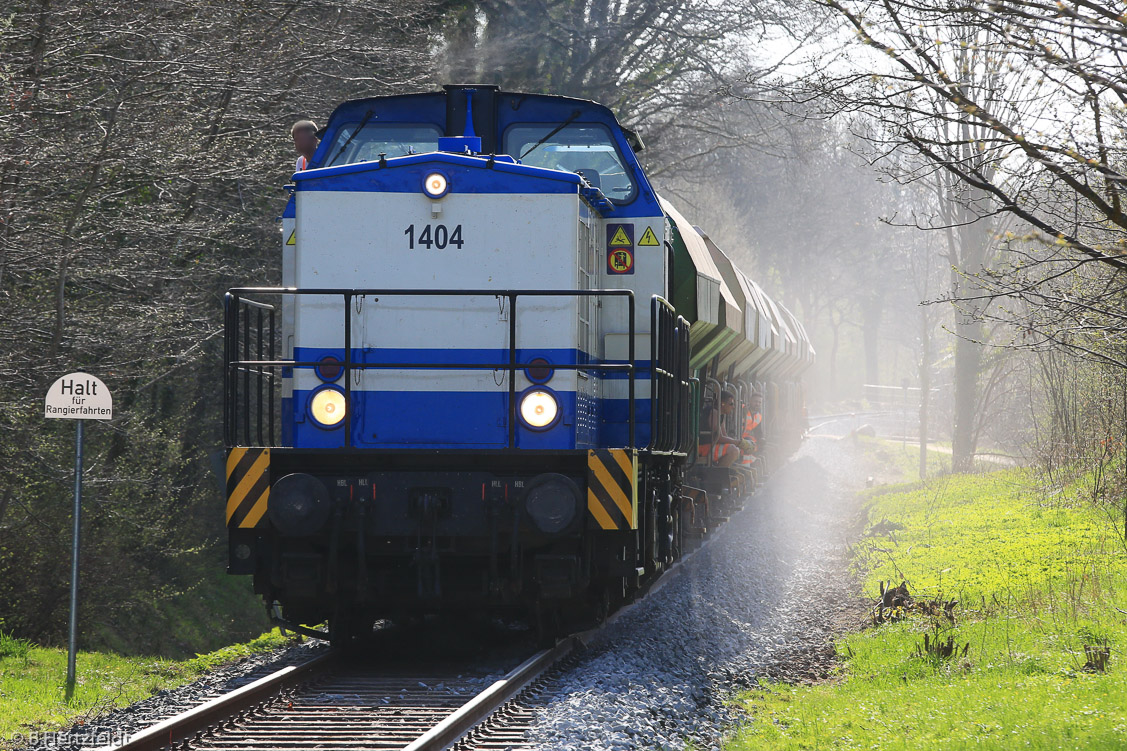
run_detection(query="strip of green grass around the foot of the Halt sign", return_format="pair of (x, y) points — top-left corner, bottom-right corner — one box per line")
(0, 630), (286, 749)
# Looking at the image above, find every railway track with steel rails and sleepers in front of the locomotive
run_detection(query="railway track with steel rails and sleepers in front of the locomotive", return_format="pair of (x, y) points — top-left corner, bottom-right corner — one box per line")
(99, 636), (580, 751)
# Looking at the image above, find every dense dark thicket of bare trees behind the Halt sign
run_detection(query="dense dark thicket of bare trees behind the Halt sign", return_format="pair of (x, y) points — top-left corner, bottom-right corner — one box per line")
(0, 0), (438, 651)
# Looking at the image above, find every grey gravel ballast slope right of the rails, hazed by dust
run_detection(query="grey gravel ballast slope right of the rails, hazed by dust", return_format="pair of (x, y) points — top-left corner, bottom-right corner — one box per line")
(531, 439), (868, 751)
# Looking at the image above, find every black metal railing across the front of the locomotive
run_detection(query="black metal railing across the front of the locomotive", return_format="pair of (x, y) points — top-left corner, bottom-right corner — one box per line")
(223, 288), (640, 449)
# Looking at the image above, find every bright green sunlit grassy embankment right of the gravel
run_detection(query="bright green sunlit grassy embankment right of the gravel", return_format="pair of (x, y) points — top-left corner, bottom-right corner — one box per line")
(727, 443), (1127, 751)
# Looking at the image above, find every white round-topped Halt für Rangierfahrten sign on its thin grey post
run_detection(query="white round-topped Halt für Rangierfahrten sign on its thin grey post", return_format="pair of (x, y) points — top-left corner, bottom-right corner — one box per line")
(43, 372), (114, 699)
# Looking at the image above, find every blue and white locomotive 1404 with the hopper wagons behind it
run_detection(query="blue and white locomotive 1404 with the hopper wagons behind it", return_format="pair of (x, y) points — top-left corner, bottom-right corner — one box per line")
(224, 86), (813, 638)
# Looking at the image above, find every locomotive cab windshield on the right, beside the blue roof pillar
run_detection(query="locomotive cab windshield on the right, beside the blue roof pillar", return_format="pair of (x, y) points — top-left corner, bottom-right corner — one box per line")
(505, 123), (635, 203)
